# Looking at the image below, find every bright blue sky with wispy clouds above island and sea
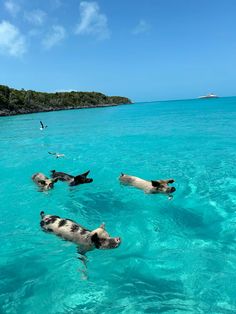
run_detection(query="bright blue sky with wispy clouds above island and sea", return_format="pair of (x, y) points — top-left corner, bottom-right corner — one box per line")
(0, 0), (236, 101)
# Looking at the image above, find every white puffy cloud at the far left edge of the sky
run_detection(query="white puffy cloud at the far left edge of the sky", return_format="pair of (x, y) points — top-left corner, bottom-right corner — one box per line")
(0, 21), (26, 57)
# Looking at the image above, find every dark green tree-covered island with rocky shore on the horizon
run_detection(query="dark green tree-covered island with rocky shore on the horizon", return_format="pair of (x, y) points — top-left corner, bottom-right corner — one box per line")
(0, 85), (131, 116)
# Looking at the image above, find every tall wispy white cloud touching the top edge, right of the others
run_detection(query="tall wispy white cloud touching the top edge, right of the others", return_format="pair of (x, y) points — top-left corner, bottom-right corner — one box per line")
(75, 1), (110, 39)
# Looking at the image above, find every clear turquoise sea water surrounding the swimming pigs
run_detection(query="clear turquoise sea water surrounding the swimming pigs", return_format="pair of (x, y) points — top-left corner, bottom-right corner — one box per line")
(0, 98), (236, 314)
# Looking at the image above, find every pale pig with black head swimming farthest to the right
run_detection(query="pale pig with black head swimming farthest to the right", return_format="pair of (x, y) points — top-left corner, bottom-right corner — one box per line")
(119, 173), (176, 197)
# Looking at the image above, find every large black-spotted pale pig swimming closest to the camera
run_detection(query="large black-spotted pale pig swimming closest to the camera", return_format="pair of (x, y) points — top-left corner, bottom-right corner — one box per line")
(40, 212), (121, 254)
